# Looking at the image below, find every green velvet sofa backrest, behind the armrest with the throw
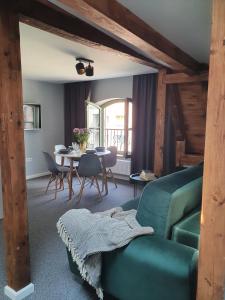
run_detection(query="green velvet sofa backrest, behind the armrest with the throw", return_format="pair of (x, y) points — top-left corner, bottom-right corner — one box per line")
(137, 164), (203, 238)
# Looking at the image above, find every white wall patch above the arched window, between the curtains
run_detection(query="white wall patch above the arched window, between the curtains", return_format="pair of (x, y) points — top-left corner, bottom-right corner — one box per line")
(91, 76), (133, 102)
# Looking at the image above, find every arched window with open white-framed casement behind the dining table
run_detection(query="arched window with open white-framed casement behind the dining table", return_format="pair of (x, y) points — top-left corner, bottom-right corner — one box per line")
(87, 99), (132, 157)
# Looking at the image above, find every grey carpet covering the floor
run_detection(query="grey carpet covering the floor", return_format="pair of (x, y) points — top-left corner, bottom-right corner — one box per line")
(0, 178), (133, 300)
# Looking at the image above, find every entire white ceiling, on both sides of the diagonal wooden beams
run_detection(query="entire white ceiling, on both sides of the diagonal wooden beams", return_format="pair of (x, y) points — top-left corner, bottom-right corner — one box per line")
(20, 0), (211, 82)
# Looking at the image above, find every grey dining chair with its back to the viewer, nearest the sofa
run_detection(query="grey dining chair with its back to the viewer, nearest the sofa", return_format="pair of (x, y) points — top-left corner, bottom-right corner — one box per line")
(77, 154), (102, 202)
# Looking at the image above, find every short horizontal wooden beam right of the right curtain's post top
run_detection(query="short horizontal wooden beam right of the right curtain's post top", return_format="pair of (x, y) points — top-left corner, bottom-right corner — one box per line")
(165, 72), (209, 84)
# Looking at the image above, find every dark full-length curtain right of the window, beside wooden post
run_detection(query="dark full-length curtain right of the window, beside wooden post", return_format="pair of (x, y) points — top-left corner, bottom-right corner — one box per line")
(131, 74), (157, 173)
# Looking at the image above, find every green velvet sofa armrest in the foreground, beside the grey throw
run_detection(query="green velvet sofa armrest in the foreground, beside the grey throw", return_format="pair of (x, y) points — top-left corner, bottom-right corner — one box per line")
(102, 236), (198, 300)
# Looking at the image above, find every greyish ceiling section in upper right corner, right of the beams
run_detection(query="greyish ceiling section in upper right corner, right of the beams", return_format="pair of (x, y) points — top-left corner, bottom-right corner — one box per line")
(117, 0), (212, 63)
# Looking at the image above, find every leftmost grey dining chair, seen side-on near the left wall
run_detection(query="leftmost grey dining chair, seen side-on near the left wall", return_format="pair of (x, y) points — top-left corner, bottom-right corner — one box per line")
(43, 152), (70, 199)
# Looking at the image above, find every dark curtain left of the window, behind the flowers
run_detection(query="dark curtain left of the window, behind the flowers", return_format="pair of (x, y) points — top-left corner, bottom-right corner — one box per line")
(64, 81), (91, 146)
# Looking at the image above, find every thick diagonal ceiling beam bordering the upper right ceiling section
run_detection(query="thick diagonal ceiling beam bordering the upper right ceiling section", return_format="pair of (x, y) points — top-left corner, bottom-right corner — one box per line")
(57, 0), (201, 72)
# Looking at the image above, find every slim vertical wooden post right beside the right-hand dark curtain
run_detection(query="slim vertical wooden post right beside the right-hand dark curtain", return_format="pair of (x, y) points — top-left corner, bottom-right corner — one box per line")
(154, 69), (167, 176)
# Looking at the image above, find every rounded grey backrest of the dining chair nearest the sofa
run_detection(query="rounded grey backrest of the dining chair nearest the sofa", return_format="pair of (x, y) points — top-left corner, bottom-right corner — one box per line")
(77, 154), (102, 177)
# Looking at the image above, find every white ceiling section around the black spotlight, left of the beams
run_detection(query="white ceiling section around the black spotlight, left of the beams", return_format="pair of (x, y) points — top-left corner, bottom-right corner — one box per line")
(20, 24), (156, 83)
